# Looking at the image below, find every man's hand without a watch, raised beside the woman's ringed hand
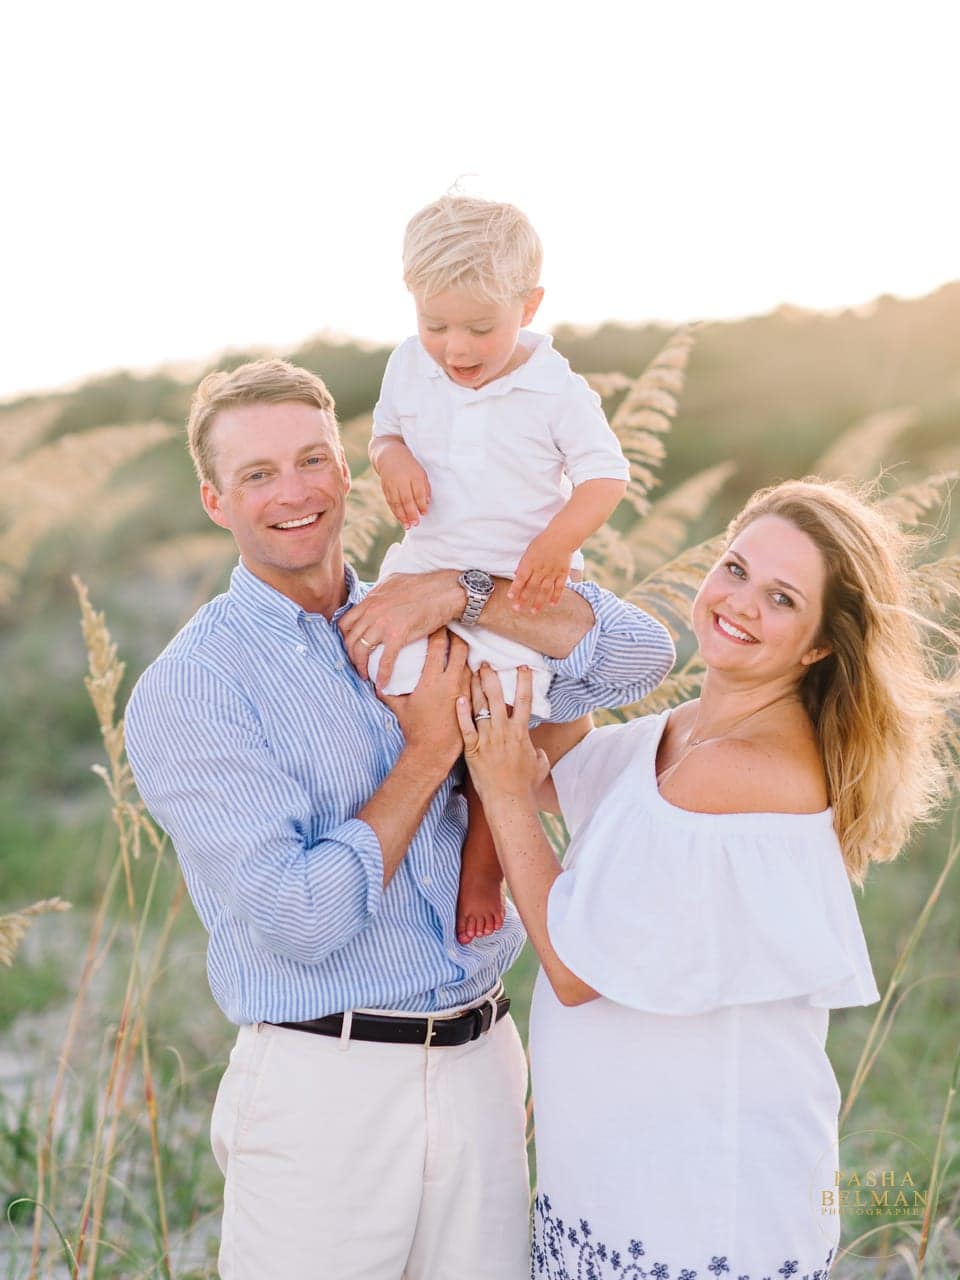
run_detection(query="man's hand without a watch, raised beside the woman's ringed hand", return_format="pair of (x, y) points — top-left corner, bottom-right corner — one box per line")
(379, 628), (470, 780)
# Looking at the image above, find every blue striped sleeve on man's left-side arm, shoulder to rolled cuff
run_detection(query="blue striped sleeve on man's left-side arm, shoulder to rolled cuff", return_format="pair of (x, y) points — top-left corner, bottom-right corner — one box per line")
(124, 660), (383, 964)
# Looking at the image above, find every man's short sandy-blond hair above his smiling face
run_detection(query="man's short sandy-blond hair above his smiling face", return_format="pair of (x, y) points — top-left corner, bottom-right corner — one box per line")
(187, 360), (340, 489)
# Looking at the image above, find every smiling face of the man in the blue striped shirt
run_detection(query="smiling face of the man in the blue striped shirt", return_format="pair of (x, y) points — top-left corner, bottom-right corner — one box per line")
(200, 401), (349, 594)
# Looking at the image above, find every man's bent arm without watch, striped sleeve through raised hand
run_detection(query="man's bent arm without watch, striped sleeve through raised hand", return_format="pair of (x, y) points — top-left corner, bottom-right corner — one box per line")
(125, 635), (466, 964)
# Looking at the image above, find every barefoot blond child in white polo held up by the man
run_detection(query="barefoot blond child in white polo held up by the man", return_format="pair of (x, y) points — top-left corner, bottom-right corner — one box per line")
(369, 196), (630, 942)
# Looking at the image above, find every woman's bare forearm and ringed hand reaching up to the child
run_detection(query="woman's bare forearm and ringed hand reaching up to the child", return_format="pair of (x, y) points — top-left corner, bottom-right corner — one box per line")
(457, 666), (599, 1005)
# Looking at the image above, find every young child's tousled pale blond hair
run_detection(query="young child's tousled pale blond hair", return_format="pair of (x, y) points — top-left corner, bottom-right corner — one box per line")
(403, 196), (543, 303)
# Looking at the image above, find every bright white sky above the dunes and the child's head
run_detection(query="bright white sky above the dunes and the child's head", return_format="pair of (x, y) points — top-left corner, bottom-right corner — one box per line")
(0, 0), (960, 397)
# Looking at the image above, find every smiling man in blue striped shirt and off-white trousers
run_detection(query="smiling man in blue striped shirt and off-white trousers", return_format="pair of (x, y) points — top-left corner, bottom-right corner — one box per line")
(127, 361), (673, 1280)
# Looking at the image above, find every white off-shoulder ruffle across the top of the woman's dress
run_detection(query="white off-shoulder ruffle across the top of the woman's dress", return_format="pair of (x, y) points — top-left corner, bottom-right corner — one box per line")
(548, 717), (879, 1015)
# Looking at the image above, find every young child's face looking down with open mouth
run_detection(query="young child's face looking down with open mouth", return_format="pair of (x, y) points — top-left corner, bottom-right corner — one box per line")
(413, 288), (543, 388)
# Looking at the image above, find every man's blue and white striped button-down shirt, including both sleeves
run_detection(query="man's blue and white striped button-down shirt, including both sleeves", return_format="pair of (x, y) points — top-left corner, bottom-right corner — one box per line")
(125, 563), (673, 1023)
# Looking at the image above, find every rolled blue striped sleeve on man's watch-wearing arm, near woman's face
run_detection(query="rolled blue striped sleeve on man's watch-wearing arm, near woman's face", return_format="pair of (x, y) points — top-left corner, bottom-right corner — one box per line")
(545, 582), (676, 721)
